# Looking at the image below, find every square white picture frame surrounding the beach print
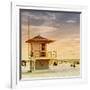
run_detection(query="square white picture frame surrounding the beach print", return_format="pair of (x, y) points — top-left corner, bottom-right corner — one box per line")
(11, 2), (87, 88)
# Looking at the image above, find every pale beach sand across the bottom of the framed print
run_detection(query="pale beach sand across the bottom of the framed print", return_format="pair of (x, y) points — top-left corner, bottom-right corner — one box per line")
(22, 63), (80, 80)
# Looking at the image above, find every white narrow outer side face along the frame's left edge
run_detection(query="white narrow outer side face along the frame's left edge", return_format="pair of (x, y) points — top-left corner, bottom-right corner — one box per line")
(11, 3), (17, 87)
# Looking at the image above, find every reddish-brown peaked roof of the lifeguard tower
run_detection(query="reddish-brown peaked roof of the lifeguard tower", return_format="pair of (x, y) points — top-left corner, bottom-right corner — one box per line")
(26, 35), (54, 43)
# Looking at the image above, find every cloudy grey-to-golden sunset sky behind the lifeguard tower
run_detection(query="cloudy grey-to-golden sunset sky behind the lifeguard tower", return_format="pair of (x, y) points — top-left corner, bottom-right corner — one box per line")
(20, 10), (80, 60)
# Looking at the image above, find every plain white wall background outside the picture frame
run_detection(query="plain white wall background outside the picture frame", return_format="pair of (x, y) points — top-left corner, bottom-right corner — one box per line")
(0, 0), (90, 90)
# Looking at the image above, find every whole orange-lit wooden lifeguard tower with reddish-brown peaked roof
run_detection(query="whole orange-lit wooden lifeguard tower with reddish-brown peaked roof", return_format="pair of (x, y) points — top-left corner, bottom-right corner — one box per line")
(26, 35), (54, 71)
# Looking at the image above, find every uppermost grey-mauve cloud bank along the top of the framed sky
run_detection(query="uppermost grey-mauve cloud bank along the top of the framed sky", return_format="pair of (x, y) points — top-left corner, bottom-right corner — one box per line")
(21, 10), (80, 28)
